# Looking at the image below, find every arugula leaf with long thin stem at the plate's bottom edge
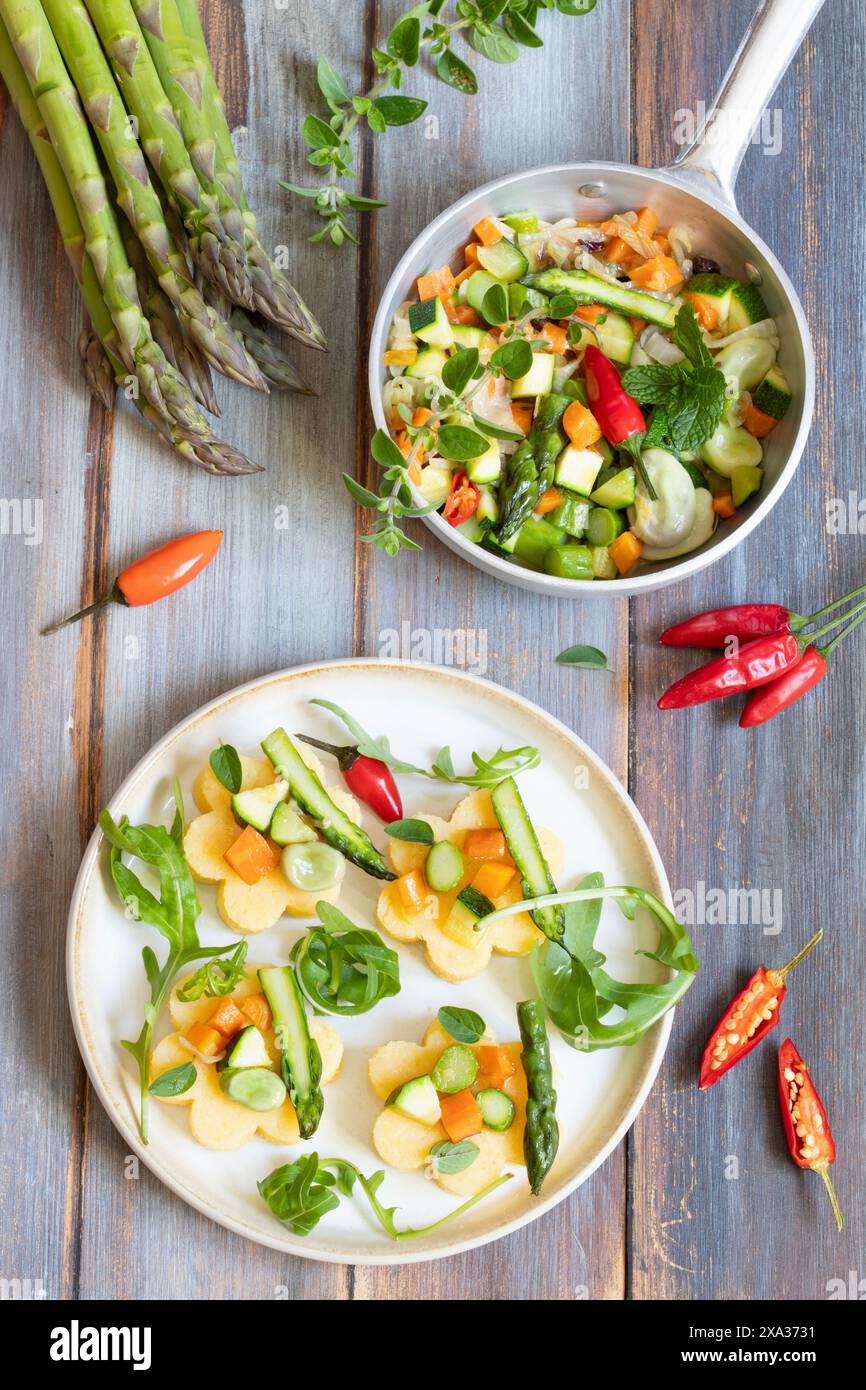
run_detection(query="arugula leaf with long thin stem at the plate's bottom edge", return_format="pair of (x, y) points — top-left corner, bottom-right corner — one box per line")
(257, 1145), (512, 1241)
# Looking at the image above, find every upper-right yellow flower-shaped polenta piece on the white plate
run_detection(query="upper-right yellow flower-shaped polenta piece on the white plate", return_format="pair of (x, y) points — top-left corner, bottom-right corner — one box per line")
(377, 791), (563, 981)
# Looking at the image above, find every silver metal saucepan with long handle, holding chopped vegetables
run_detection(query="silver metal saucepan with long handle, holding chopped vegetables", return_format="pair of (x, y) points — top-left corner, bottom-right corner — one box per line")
(370, 0), (823, 598)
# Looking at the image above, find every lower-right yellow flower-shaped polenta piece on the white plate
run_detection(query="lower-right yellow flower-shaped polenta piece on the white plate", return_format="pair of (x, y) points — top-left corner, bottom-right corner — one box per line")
(368, 1020), (527, 1197)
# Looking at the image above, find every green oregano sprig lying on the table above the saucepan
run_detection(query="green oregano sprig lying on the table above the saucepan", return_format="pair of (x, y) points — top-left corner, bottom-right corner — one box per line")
(279, 0), (596, 246)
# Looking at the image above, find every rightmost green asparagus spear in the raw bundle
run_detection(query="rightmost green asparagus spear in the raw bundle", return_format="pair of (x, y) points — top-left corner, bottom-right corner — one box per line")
(175, 0), (325, 350)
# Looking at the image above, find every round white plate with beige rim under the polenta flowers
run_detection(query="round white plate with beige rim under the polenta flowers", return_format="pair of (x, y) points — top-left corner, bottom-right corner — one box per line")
(67, 659), (671, 1265)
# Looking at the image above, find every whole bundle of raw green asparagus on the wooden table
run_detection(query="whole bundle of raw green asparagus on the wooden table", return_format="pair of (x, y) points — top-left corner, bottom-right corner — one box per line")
(0, 0), (325, 474)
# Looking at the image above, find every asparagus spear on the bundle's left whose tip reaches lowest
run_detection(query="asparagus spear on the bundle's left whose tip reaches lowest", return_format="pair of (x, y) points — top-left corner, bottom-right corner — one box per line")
(0, 0), (257, 474)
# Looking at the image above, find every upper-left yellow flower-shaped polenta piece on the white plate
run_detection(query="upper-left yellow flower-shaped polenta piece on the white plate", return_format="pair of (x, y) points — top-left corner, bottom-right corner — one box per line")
(183, 751), (360, 935)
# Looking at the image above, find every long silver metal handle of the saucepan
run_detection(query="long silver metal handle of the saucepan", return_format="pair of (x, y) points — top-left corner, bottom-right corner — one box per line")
(666, 0), (824, 204)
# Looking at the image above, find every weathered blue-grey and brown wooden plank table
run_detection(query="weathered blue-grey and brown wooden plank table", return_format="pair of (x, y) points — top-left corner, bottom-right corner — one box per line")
(0, 0), (866, 1300)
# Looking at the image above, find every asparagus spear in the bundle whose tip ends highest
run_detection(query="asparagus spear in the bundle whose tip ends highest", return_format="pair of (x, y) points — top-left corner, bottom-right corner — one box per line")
(85, 0), (253, 309)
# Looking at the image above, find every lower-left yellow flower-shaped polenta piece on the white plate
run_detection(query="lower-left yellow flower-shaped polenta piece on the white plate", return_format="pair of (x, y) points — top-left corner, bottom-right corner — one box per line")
(150, 972), (343, 1152)
